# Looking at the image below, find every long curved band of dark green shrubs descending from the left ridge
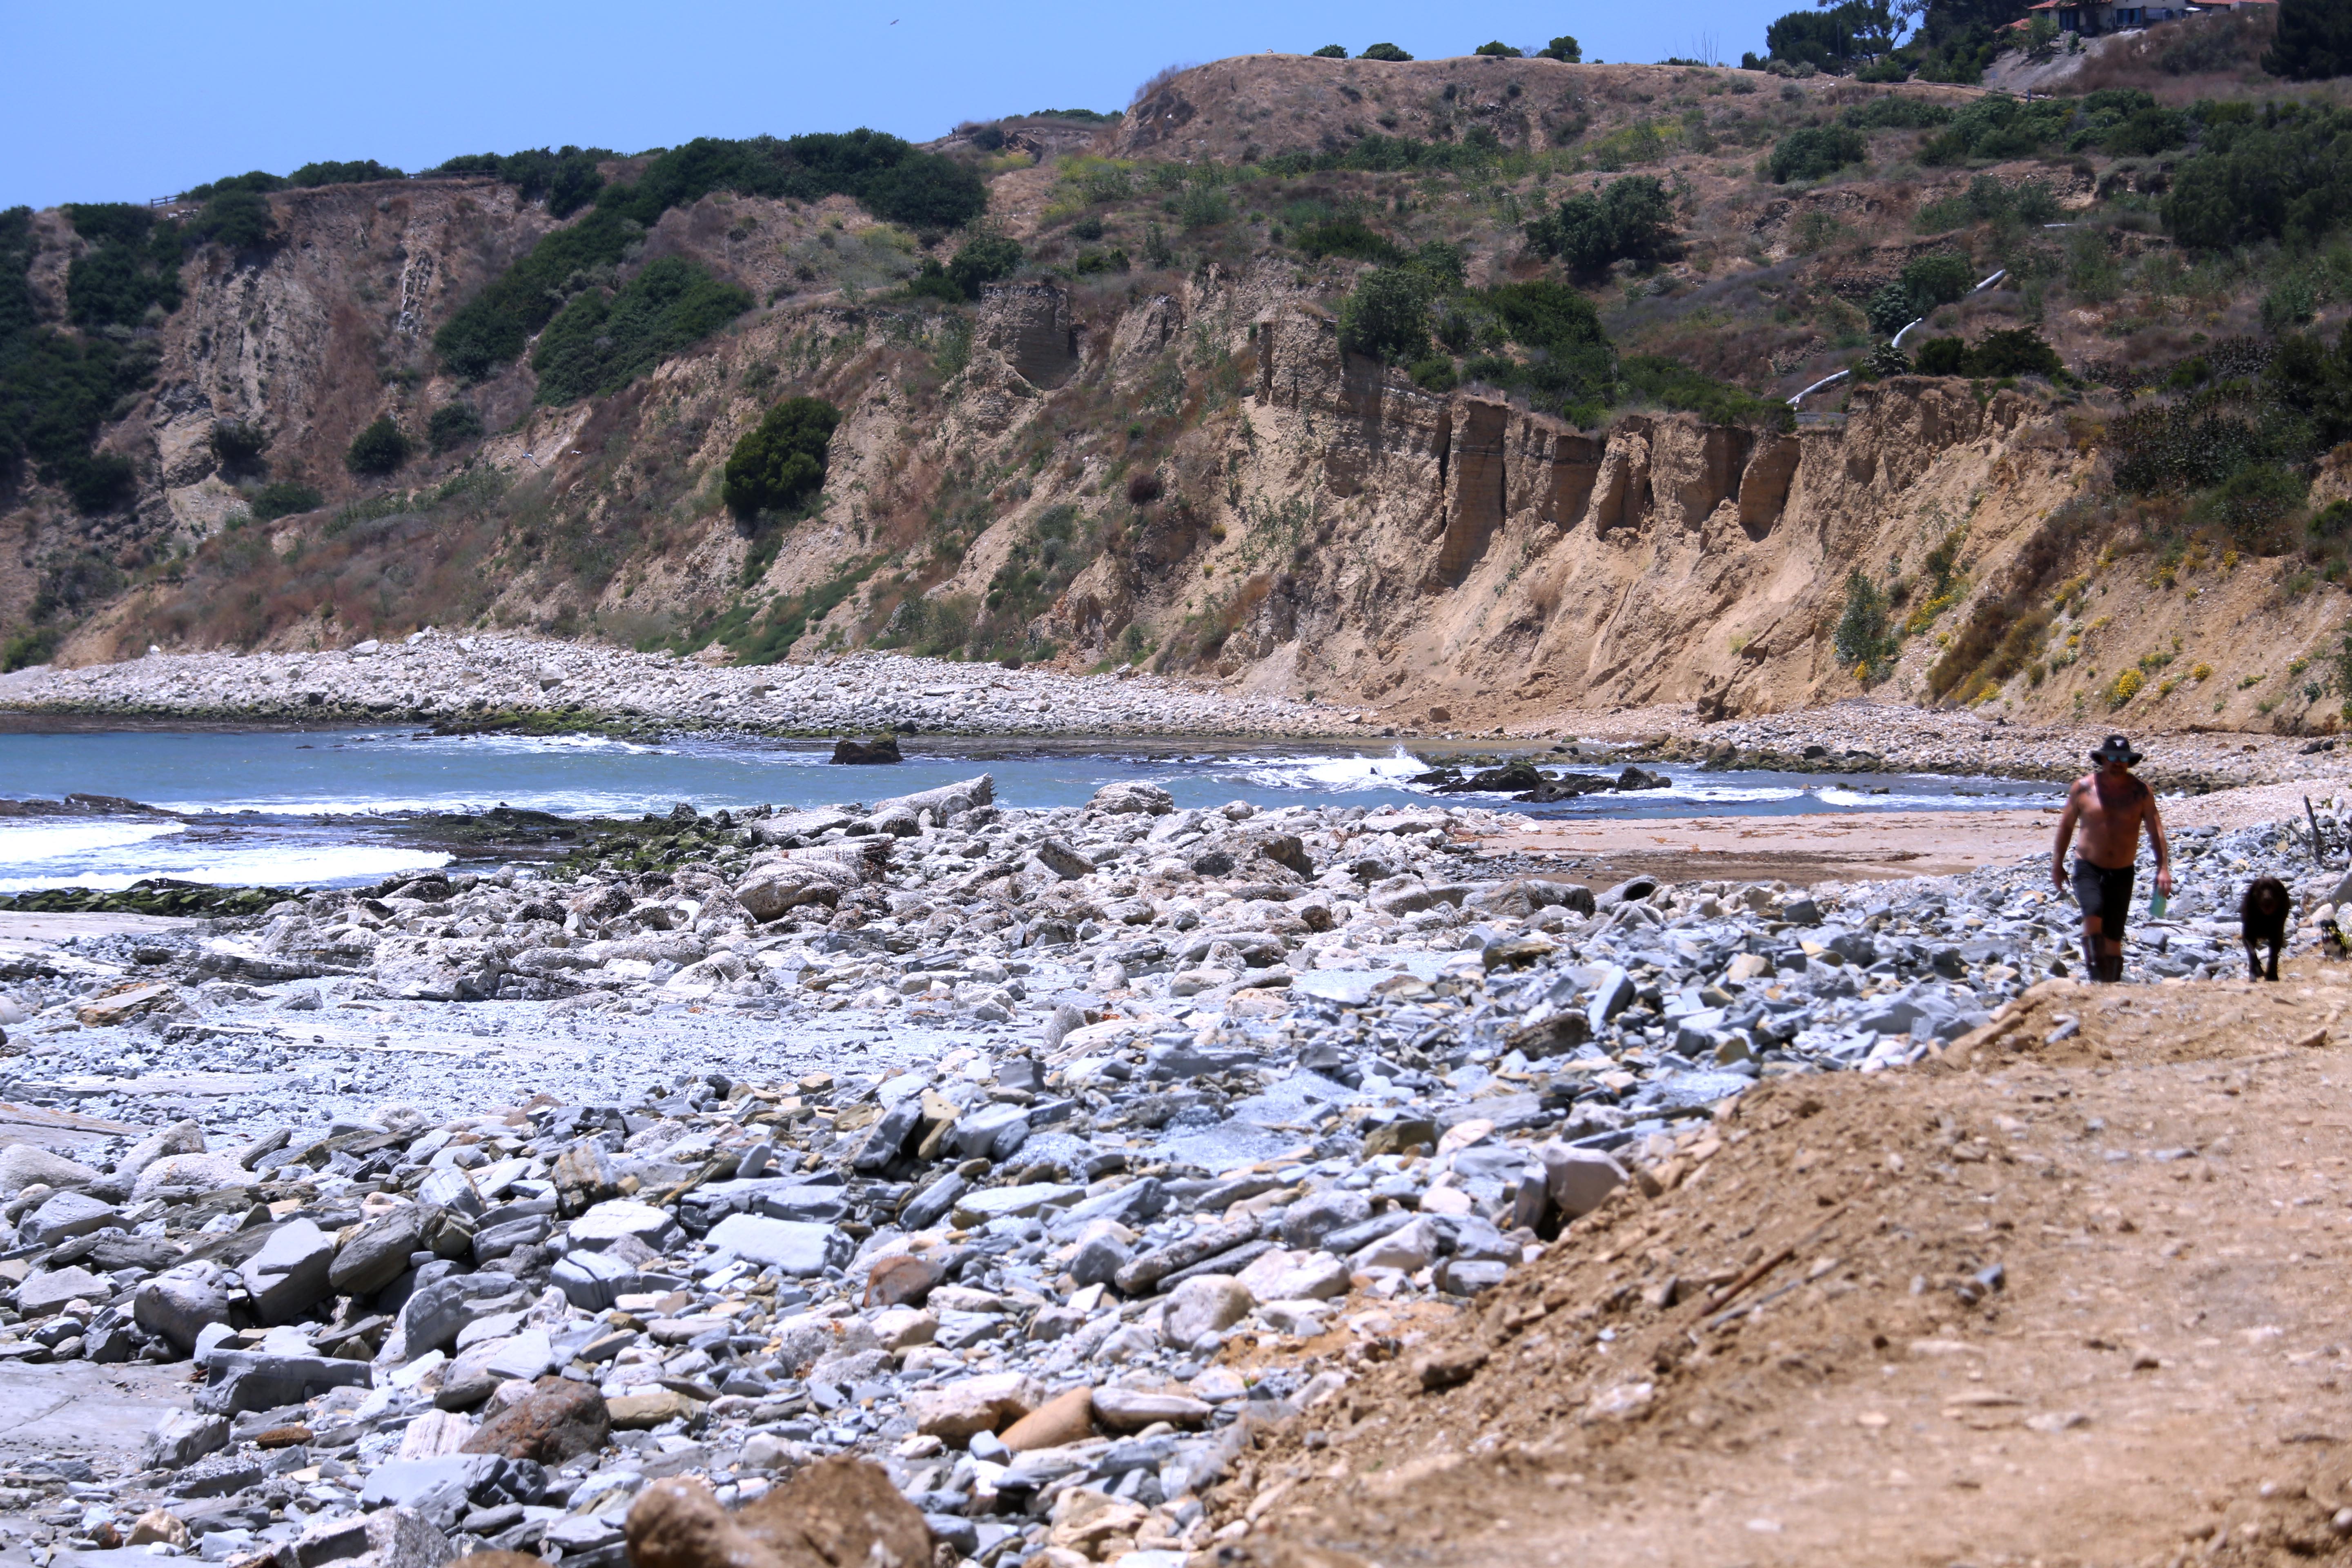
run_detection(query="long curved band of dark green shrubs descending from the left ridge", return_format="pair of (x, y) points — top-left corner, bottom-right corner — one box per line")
(433, 129), (988, 381)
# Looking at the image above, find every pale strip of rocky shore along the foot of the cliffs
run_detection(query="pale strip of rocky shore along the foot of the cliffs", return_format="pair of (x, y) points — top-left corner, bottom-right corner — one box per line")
(18, 630), (2352, 792)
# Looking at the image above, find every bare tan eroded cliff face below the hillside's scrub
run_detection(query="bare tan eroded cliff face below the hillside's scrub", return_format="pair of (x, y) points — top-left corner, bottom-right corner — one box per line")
(23, 181), (2328, 729)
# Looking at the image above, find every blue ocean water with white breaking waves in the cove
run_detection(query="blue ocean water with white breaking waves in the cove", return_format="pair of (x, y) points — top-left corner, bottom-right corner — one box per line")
(0, 729), (2056, 893)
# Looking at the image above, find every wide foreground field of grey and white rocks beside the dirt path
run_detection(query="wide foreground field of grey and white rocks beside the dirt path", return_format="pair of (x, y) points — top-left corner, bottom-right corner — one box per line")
(0, 776), (2352, 1568)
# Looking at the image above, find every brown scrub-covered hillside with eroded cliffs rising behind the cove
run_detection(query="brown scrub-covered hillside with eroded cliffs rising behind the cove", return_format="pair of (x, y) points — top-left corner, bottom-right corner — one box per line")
(0, 44), (2352, 731)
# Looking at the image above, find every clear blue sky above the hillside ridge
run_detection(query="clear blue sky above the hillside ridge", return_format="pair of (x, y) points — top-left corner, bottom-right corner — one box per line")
(0, 0), (1802, 207)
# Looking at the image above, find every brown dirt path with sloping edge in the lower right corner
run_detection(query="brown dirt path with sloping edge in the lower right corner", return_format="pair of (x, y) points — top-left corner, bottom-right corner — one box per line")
(1214, 964), (2352, 1568)
